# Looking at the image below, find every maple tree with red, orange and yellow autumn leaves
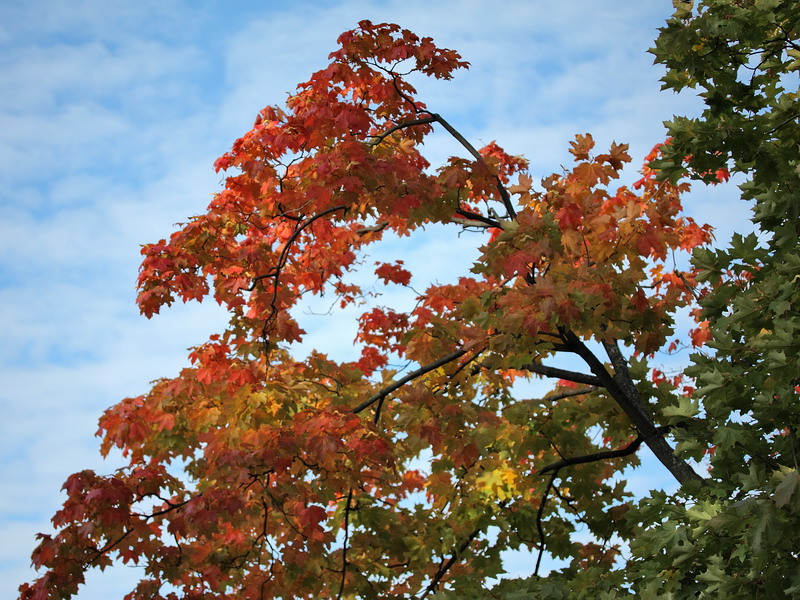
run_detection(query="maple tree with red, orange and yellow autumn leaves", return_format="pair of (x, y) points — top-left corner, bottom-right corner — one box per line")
(15, 9), (800, 600)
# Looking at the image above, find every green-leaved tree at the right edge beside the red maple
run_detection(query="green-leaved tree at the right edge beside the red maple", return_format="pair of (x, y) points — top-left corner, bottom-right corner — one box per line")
(620, 0), (800, 598)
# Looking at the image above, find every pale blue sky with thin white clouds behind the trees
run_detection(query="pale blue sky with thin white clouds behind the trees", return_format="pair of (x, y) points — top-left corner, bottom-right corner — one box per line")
(0, 0), (750, 600)
